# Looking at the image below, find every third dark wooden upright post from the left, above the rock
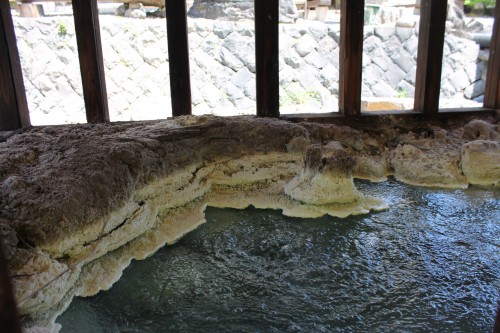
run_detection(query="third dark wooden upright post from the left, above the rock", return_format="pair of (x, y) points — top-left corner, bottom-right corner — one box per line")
(165, 0), (191, 117)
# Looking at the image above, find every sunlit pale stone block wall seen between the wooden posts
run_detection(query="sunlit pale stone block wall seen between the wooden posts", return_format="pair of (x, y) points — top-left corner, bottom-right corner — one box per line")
(14, 16), (487, 125)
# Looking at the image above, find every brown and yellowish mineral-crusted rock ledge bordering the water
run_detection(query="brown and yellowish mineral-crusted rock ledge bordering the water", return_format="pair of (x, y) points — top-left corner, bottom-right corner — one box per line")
(0, 117), (500, 331)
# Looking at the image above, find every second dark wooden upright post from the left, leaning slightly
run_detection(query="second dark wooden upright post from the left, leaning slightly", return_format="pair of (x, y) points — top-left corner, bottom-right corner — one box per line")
(73, 0), (109, 123)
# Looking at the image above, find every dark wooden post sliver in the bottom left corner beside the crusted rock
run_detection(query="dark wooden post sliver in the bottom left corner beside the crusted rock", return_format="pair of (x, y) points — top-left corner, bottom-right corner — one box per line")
(0, 238), (21, 333)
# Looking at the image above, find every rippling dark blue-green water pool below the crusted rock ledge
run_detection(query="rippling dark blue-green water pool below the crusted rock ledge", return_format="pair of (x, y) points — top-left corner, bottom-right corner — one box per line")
(57, 181), (500, 333)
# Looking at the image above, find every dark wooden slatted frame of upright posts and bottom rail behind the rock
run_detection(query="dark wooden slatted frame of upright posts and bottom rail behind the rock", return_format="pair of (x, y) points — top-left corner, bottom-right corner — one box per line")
(0, 0), (500, 131)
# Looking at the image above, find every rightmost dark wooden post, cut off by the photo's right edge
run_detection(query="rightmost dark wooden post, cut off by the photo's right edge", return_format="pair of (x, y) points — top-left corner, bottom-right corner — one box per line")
(484, 2), (500, 110)
